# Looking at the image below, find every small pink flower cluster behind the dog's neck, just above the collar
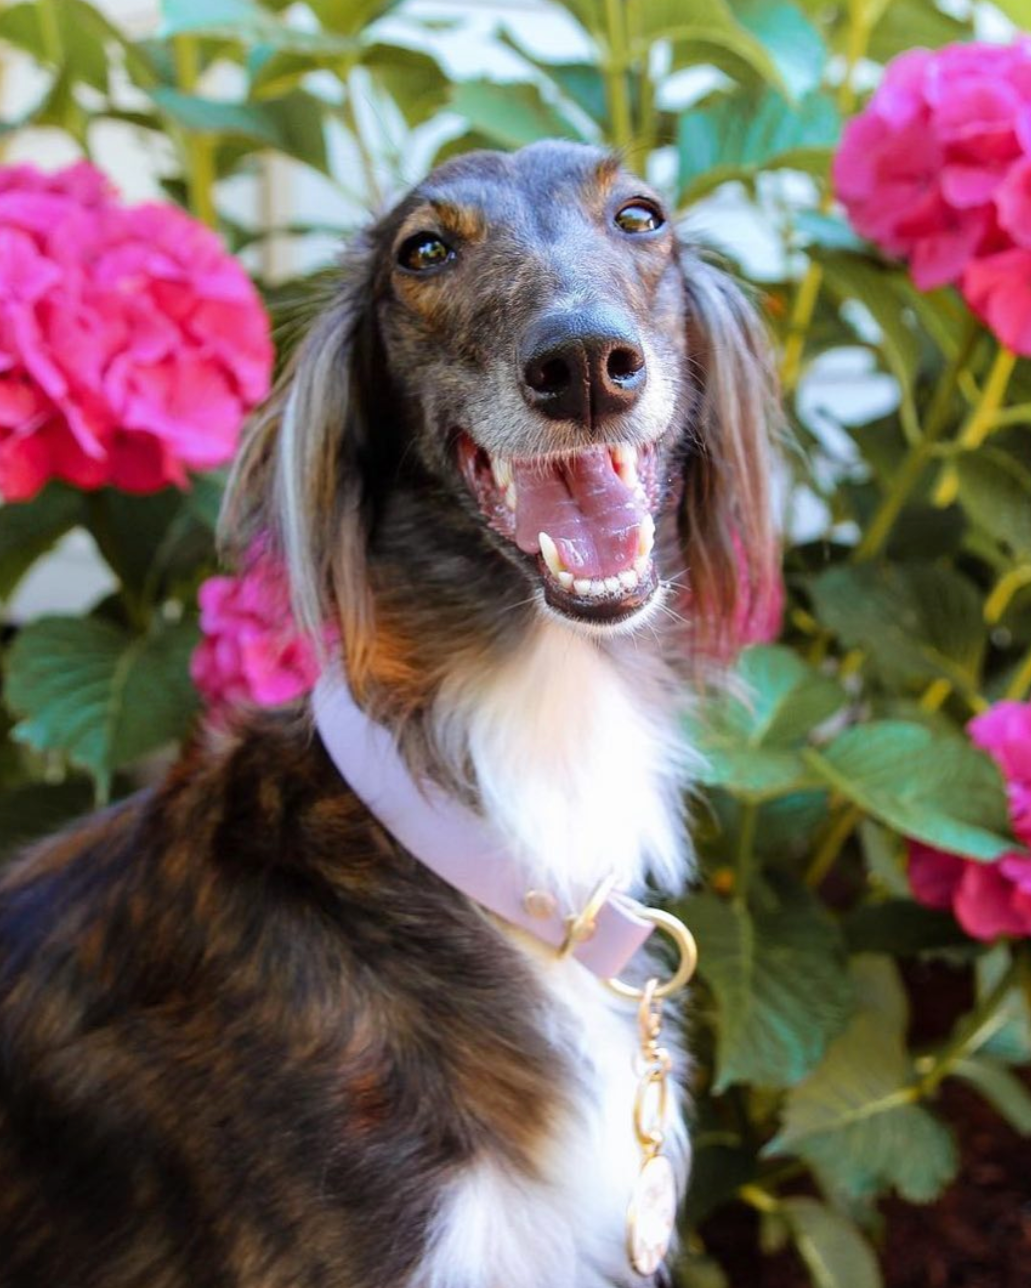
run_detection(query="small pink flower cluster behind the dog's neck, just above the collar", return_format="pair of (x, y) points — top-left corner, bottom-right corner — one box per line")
(189, 551), (329, 714)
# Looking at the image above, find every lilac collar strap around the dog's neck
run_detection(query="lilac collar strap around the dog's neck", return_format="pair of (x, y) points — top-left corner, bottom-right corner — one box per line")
(312, 671), (655, 979)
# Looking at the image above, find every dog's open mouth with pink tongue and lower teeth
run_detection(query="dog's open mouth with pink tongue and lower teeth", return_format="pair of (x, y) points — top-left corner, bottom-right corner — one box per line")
(459, 433), (659, 621)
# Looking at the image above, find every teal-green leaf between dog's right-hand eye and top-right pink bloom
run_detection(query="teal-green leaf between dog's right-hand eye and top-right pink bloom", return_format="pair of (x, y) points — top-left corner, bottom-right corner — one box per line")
(677, 90), (840, 201)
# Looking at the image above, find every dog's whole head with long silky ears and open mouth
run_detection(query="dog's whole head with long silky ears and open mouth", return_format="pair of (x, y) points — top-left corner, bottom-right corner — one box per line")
(228, 143), (776, 683)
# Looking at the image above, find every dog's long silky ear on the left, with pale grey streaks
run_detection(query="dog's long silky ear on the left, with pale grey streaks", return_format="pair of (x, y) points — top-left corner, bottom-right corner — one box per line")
(220, 234), (375, 670)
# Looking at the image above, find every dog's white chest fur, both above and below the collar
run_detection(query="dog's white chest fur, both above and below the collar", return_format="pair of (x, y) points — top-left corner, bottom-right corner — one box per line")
(418, 623), (688, 1288)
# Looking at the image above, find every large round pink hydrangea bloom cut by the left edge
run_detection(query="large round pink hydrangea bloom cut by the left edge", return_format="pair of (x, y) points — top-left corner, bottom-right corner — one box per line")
(0, 164), (272, 501)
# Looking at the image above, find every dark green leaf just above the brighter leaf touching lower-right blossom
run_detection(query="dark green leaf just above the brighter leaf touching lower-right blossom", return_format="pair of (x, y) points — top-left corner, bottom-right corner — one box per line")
(812, 563), (987, 694)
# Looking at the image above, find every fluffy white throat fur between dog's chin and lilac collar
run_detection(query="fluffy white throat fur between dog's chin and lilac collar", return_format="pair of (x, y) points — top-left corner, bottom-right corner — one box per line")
(427, 621), (689, 902)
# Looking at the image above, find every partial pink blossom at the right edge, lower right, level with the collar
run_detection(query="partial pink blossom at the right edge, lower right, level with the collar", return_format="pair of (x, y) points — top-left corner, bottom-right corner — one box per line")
(909, 702), (1031, 939)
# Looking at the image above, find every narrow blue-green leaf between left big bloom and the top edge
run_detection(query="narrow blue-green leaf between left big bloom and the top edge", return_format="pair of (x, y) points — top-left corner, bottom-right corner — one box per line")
(151, 86), (329, 173)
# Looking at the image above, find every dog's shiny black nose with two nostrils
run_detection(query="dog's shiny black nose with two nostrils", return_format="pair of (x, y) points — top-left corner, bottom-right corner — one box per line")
(523, 305), (648, 426)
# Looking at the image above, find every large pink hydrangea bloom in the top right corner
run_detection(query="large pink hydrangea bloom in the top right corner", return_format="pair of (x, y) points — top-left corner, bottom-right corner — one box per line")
(834, 40), (1031, 290)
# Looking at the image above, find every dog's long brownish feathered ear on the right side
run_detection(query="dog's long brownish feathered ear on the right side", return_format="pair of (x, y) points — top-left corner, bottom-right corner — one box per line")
(678, 250), (781, 661)
